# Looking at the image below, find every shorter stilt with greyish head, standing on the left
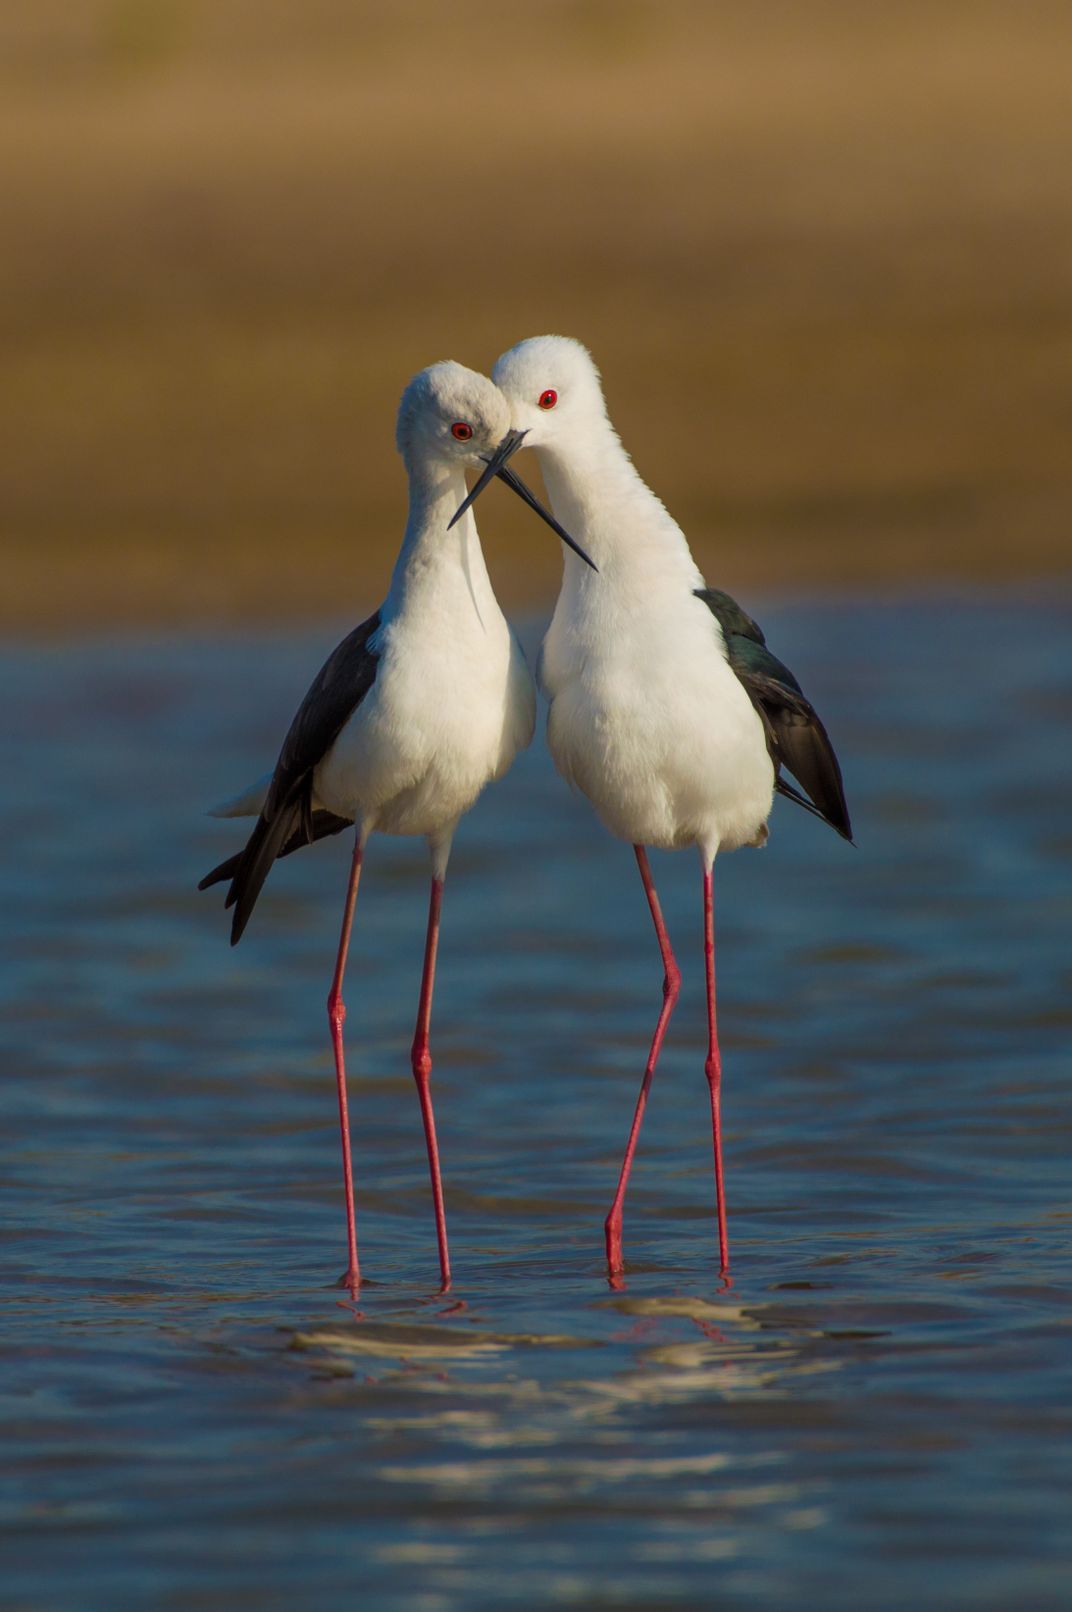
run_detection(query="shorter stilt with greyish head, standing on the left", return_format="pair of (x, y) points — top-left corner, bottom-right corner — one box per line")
(200, 363), (593, 1291)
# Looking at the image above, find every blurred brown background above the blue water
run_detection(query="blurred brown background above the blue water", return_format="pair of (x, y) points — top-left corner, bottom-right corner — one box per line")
(0, 0), (1072, 630)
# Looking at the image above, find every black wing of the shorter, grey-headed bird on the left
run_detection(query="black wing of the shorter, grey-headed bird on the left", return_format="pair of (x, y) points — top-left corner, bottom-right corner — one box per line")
(198, 611), (380, 946)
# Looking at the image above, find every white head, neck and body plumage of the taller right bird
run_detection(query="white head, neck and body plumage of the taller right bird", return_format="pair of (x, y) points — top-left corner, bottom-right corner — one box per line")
(493, 337), (774, 866)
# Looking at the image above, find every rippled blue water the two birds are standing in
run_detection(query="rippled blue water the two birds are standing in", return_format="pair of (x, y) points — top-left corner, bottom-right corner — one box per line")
(0, 596), (1072, 1612)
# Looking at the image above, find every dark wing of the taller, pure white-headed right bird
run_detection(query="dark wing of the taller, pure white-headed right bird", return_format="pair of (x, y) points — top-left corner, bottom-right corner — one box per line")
(695, 588), (853, 840)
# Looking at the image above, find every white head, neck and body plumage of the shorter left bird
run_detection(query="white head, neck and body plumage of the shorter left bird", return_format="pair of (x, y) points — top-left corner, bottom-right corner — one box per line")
(214, 363), (535, 877)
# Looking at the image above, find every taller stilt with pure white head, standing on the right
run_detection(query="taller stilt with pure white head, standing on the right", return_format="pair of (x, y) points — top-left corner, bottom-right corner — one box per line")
(480, 335), (851, 1278)
